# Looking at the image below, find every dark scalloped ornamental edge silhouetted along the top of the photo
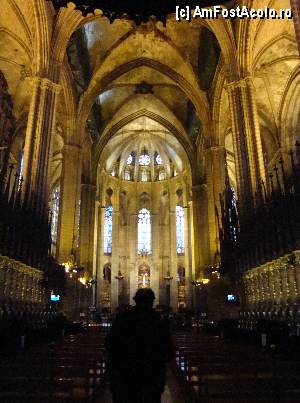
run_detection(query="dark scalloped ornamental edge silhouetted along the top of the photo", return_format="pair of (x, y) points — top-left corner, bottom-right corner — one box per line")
(48, 0), (226, 24)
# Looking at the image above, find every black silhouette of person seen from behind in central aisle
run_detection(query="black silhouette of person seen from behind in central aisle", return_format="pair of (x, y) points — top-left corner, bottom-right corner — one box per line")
(106, 288), (173, 403)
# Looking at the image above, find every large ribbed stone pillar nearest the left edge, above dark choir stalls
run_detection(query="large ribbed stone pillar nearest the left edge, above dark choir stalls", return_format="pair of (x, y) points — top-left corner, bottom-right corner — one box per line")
(23, 77), (61, 203)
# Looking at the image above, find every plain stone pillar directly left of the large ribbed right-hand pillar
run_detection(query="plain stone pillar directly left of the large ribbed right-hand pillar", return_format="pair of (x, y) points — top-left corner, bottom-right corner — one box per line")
(205, 147), (225, 265)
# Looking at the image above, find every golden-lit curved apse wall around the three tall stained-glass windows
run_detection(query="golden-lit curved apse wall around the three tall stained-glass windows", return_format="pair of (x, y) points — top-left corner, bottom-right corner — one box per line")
(95, 170), (194, 310)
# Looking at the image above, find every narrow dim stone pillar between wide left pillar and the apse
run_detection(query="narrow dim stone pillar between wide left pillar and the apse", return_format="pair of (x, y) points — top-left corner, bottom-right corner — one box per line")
(79, 184), (96, 277)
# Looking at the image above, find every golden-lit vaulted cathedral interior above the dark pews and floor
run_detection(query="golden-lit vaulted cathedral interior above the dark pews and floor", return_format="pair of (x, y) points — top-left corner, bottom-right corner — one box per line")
(0, 0), (300, 402)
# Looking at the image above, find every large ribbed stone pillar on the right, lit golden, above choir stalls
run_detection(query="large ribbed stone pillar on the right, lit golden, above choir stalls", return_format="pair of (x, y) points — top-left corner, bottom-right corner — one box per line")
(227, 77), (265, 212)
